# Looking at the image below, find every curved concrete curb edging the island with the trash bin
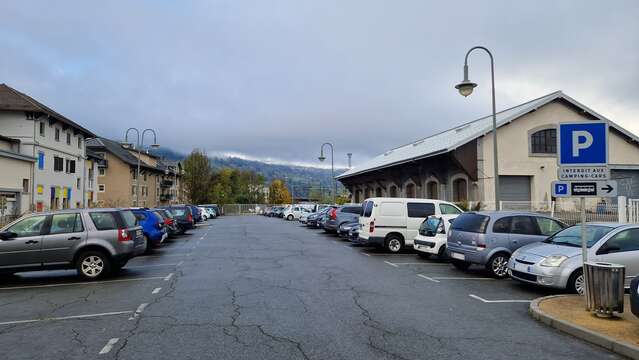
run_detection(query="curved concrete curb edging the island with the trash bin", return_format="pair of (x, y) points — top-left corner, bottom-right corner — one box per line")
(529, 295), (639, 360)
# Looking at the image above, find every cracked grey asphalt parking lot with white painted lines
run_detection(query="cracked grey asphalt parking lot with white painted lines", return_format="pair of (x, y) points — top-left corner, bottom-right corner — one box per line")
(0, 216), (619, 360)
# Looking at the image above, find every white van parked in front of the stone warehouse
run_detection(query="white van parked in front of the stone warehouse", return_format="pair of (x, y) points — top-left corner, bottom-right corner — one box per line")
(359, 198), (463, 253)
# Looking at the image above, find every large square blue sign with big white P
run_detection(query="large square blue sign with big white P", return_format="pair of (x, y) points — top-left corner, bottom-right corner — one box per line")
(557, 121), (608, 166)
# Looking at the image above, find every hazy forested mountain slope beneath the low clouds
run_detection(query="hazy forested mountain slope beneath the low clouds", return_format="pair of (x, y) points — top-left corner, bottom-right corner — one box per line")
(153, 148), (346, 197)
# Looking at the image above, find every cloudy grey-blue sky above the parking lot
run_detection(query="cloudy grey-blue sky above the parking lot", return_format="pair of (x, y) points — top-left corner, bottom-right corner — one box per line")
(0, 0), (639, 166)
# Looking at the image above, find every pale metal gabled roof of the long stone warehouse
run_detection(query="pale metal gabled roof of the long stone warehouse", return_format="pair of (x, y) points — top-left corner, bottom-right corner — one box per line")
(336, 91), (639, 179)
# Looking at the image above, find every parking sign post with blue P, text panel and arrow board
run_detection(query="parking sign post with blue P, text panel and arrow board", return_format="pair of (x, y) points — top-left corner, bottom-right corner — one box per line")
(552, 121), (617, 304)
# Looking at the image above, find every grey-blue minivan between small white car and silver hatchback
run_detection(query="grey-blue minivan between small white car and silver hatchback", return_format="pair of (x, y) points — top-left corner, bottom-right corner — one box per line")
(446, 211), (567, 278)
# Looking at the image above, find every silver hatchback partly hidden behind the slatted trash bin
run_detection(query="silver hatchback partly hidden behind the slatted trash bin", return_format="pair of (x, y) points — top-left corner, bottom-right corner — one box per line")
(508, 223), (639, 294)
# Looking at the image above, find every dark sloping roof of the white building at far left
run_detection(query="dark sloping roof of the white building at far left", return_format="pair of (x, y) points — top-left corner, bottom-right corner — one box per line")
(0, 84), (96, 137)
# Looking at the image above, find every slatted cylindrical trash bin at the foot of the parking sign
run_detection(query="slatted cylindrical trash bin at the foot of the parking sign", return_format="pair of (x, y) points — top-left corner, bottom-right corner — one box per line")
(584, 262), (626, 317)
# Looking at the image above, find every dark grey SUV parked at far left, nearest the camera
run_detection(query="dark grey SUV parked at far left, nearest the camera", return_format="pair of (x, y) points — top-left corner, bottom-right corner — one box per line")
(0, 209), (146, 280)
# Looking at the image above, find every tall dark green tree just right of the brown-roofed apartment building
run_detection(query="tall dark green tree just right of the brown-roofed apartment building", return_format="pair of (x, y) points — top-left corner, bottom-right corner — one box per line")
(182, 149), (211, 204)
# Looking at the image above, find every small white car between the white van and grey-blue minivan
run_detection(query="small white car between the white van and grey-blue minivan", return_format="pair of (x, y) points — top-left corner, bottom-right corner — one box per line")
(413, 214), (459, 259)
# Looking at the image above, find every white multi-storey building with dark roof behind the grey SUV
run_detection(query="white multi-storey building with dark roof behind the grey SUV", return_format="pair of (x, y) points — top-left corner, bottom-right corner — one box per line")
(0, 84), (95, 212)
